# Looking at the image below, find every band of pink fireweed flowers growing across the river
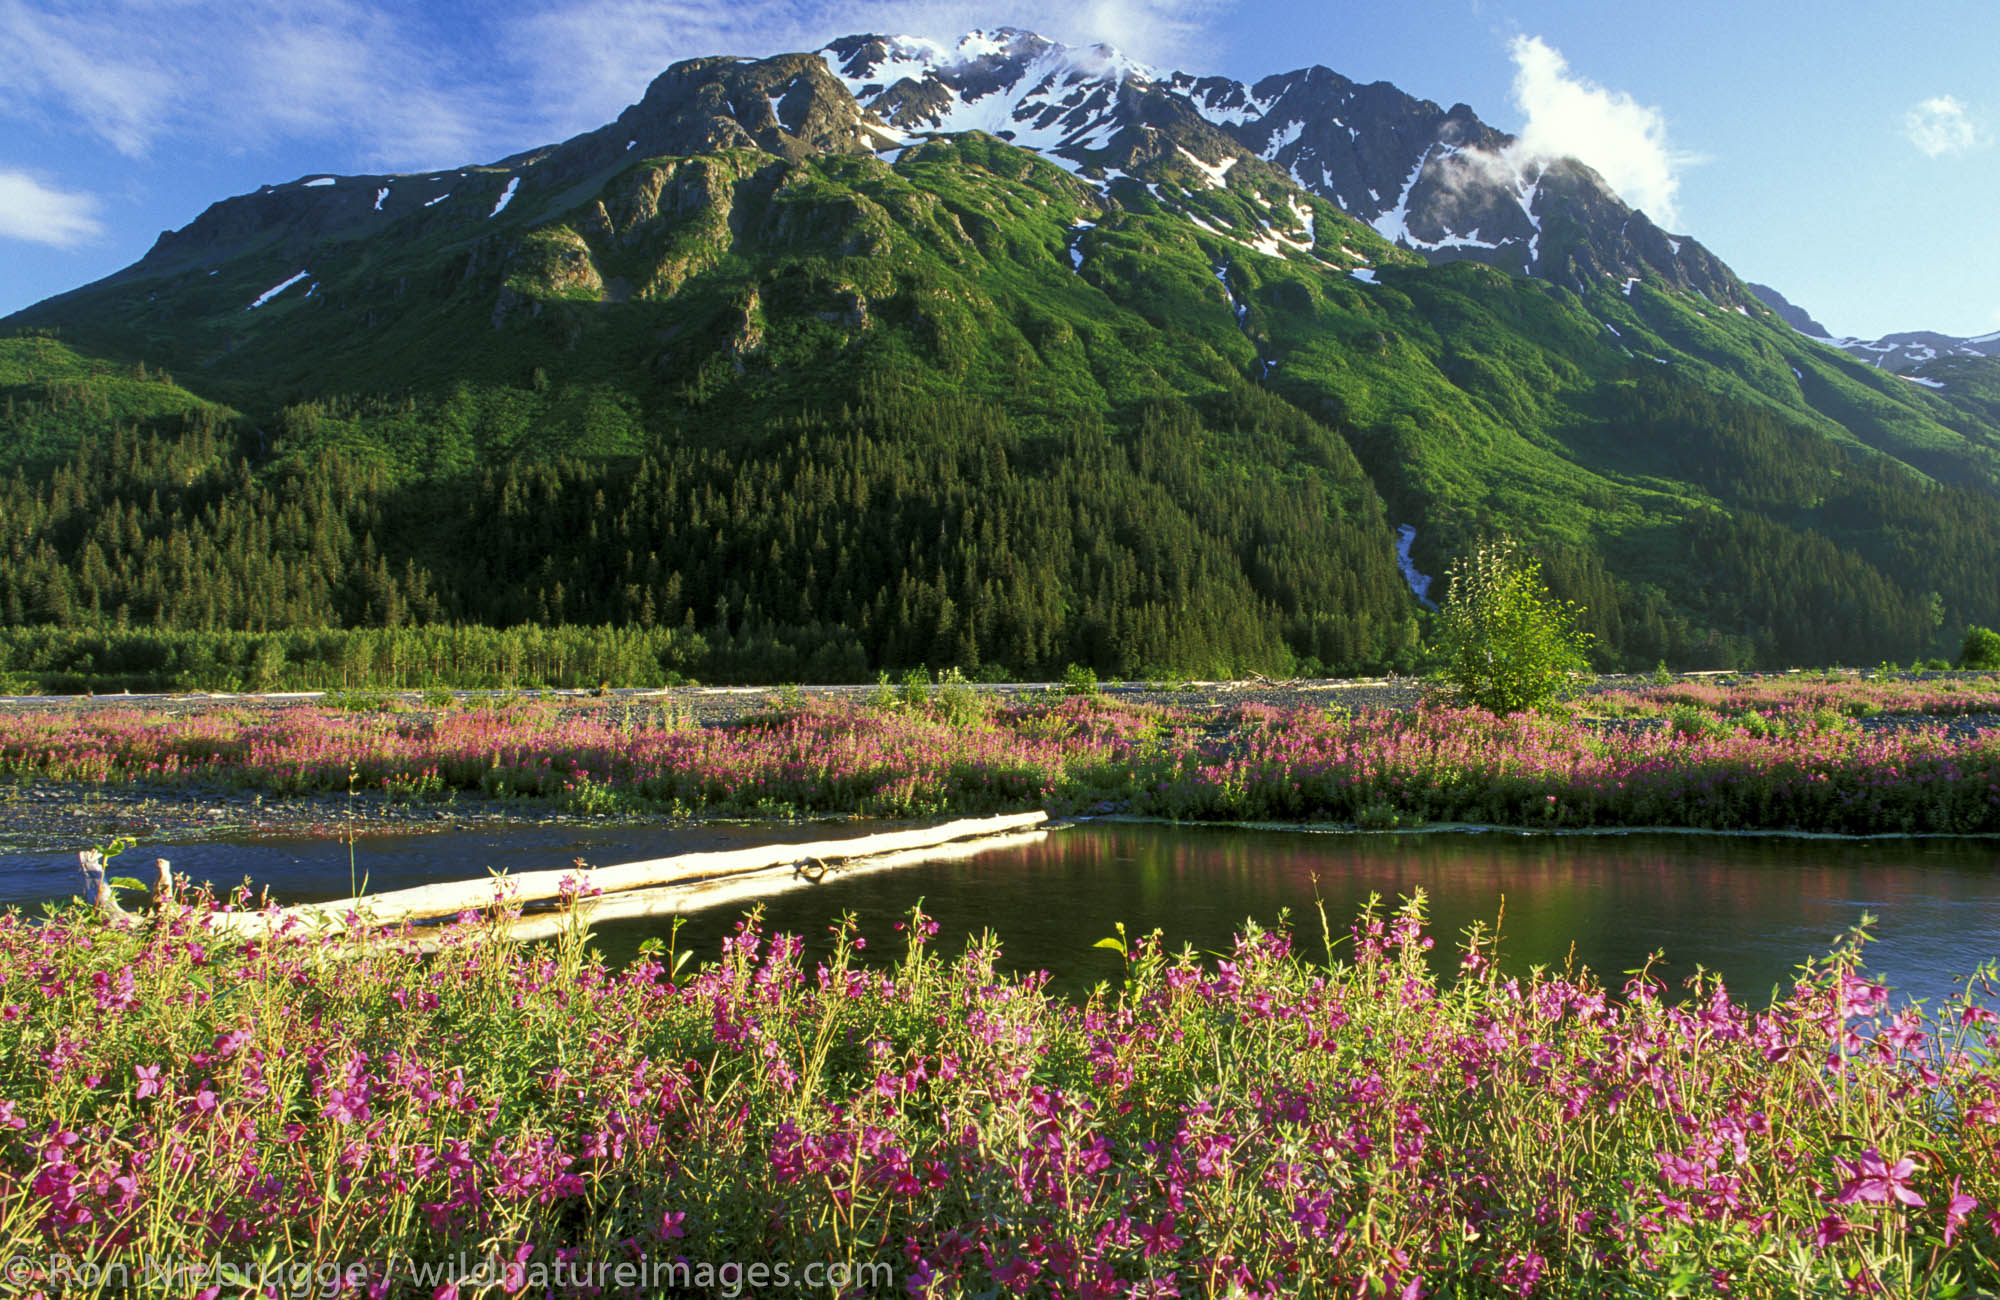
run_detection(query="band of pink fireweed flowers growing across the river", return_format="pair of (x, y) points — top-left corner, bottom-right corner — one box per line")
(0, 682), (2000, 834)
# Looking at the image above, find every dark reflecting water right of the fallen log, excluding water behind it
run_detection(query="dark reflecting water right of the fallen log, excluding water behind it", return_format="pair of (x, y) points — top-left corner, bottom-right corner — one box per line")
(632, 824), (2000, 998)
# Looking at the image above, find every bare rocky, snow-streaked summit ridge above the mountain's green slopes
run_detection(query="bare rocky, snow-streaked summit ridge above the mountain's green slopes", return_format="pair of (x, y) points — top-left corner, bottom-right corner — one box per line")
(822, 30), (1742, 306)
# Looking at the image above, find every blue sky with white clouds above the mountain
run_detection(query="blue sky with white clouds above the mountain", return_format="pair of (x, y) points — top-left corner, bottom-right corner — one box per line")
(0, 0), (2000, 336)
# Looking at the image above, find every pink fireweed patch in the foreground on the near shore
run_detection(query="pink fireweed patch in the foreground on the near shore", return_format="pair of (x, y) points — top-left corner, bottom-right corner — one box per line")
(0, 896), (2000, 1298)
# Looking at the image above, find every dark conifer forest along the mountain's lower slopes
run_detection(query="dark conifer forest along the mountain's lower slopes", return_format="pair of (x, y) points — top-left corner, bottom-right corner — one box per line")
(0, 350), (2000, 686)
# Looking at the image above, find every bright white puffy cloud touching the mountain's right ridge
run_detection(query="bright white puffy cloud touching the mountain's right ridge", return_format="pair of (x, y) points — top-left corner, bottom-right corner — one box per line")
(1508, 36), (1694, 228)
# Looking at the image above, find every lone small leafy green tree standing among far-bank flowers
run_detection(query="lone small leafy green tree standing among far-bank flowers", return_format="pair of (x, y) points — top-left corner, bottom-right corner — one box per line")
(1436, 542), (1594, 714)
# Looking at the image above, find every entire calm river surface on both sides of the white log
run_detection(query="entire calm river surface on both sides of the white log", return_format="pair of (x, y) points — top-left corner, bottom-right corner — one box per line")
(0, 822), (2000, 1000)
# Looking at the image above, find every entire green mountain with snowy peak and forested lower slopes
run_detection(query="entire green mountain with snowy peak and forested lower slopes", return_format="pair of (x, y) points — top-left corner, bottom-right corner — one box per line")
(0, 30), (2000, 678)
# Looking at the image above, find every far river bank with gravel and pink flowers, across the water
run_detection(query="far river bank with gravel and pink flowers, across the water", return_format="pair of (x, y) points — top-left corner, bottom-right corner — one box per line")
(0, 674), (2000, 848)
